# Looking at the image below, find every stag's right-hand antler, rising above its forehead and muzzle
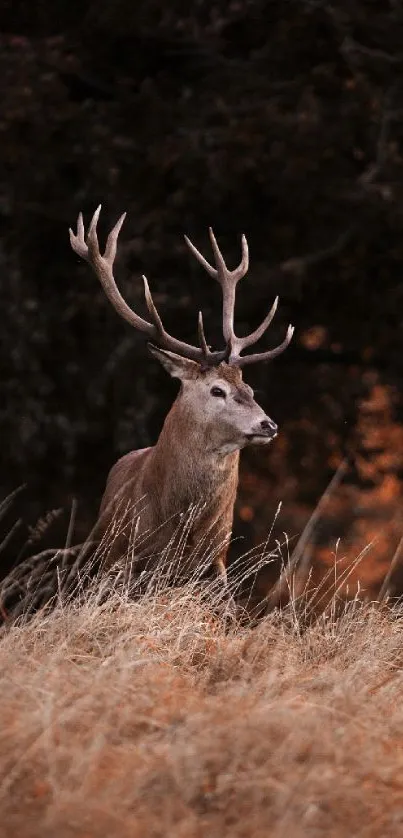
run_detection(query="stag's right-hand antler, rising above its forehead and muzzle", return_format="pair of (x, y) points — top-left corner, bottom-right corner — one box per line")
(185, 227), (294, 367)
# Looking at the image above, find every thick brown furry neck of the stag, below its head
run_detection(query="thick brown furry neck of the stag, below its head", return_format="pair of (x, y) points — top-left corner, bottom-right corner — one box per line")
(153, 398), (239, 508)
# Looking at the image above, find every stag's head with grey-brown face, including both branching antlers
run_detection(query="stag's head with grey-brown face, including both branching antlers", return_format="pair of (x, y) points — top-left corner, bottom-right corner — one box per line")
(70, 207), (294, 454)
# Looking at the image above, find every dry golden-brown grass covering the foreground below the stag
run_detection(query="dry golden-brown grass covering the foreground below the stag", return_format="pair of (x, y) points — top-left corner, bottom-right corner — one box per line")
(0, 587), (403, 838)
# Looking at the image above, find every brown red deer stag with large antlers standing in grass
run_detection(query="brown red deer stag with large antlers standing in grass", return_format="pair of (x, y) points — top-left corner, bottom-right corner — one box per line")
(69, 206), (294, 595)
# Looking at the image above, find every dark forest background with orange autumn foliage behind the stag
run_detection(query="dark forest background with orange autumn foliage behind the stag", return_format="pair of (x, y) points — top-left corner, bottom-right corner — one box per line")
(0, 0), (403, 592)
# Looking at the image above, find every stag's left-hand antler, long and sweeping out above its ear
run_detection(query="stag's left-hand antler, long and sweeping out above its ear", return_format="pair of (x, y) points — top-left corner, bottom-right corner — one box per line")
(69, 205), (226, 365)
